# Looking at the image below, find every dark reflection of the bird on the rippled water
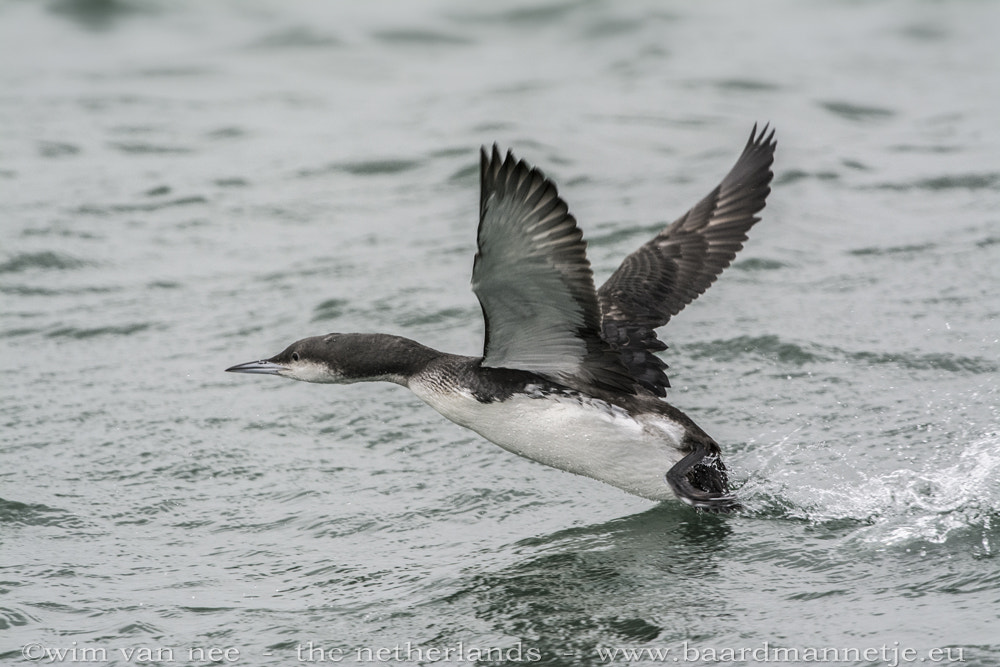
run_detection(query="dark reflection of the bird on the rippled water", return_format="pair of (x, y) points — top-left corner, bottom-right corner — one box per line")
(441, 503), (732, 665)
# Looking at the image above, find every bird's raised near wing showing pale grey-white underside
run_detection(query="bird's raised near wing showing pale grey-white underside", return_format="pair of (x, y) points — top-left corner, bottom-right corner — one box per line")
(472, 145), (635, 393)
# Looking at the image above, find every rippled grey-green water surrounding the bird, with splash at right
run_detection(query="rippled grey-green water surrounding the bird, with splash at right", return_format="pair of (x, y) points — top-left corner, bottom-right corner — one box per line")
(0, 0), (1000, 667)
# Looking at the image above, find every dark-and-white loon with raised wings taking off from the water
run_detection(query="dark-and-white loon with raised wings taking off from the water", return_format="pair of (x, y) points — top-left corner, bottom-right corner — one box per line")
(226, 124), (777, 512)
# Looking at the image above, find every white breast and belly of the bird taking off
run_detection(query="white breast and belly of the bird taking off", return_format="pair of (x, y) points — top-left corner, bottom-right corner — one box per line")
(409, 381), (684, 500)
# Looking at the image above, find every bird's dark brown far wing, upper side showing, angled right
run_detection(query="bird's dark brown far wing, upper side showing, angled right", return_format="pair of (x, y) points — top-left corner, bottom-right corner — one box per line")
(597, 125), (776, 396)
